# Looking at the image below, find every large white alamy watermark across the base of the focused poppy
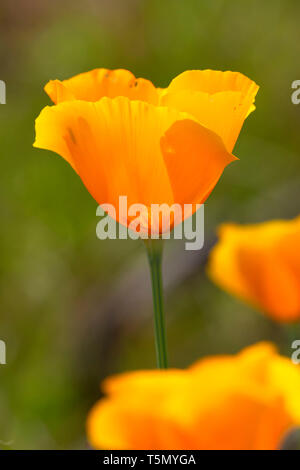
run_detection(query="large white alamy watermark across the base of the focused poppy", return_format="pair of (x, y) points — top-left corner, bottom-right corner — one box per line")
(96, 196), (204, 250)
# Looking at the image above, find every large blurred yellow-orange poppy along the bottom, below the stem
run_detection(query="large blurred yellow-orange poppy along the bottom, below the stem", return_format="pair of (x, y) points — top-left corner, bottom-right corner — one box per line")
(87, 343), (300, 450)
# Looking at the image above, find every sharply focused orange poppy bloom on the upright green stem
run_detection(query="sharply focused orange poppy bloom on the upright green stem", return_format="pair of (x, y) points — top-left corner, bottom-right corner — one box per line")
(34, 69), (258, 230)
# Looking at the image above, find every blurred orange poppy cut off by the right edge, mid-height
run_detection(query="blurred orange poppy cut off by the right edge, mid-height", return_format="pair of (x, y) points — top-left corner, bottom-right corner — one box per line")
(208, 217), (300, 322)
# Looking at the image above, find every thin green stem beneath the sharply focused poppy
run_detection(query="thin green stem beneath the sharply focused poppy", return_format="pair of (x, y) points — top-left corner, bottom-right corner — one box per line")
(145, 239), (168, 369)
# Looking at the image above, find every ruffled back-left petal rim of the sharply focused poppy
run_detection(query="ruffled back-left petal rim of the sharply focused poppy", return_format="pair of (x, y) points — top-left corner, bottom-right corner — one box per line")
(45, 68), (158, 104)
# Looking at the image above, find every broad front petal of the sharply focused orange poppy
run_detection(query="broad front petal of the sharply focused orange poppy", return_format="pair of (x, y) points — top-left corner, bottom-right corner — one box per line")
(34, 97), (233, 231)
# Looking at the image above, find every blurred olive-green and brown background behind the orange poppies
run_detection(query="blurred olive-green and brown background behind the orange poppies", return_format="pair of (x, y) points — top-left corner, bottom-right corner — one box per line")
(0, 0), (300, 449)
